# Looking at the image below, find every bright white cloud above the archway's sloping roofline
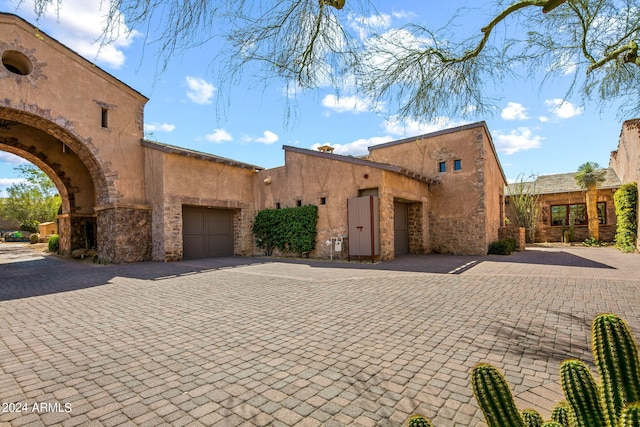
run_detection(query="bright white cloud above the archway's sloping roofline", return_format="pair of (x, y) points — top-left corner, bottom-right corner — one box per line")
(15, 0), (140, 69)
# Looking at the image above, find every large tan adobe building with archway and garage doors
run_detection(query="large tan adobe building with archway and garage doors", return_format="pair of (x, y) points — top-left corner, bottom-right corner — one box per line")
(0, 13), (506, 263)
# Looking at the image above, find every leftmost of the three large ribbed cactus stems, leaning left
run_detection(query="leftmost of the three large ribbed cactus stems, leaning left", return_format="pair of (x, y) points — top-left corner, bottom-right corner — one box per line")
(471, 363), (526, 427)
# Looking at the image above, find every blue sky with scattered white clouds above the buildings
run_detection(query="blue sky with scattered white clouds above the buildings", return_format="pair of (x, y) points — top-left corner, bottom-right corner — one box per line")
(0, 0), (631, 195)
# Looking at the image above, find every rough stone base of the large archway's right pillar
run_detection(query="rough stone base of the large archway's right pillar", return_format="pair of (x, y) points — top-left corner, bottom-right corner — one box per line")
(97, 206), (152, 264)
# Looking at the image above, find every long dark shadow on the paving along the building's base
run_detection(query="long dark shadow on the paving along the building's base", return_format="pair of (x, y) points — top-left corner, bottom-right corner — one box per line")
(0, 246), (614, 301)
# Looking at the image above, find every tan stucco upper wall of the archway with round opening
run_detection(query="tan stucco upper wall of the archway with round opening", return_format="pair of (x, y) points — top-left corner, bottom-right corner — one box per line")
(0, 14), (147, 205)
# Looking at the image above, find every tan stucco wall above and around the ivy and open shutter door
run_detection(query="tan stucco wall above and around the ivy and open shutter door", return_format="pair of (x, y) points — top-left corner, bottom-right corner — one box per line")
(255, 151), (427, 259)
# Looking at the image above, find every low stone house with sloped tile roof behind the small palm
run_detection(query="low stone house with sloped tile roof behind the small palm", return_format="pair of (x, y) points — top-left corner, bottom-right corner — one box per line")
(506, 168), (620, 242)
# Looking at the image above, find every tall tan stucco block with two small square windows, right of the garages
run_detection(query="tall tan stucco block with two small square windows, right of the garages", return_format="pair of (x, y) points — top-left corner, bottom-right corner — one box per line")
(369, 123), (505, 254)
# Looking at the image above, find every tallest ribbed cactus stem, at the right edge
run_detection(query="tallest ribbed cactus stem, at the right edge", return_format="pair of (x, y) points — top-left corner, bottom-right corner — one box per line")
(592, 314), (640, 427)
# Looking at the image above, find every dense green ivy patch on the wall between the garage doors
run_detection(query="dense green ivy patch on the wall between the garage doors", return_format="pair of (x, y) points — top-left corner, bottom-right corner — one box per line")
(253, 205), (318, 255)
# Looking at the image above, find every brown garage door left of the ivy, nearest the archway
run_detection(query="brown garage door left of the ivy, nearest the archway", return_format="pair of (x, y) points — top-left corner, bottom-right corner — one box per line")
(182, 206), (233, 259)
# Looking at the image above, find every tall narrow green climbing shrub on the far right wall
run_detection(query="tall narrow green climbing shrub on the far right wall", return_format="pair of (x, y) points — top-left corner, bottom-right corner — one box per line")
(613, 183), (638, 252)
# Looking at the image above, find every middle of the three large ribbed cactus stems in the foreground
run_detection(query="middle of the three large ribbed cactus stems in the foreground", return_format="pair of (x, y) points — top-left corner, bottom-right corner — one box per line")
(560, 359), (606, 427)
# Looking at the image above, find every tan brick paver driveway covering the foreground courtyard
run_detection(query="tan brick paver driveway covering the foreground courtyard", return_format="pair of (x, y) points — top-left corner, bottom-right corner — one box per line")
(0, 244), (640, 426)
